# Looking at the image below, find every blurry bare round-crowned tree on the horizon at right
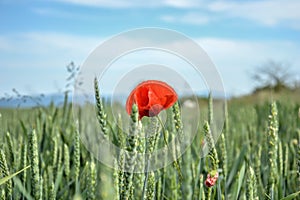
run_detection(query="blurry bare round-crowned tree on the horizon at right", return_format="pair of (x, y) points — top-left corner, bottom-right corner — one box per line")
(251, 60), (292, 91)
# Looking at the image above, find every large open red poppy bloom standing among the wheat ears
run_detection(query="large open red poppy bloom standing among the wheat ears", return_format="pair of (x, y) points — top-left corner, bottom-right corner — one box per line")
(126, 80), (177, 119)
